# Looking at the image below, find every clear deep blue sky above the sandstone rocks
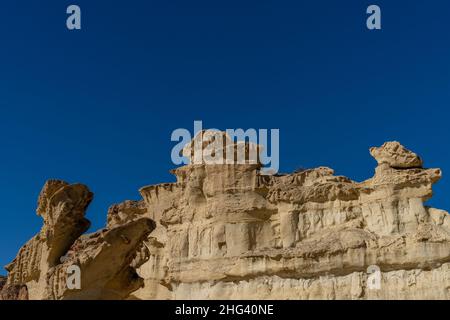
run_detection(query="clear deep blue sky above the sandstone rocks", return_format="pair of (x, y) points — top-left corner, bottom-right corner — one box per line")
(0, 0), (450, 273)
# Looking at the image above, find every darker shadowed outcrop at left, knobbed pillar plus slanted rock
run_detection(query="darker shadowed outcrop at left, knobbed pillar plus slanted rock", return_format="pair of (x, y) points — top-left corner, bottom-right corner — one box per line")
(2, 180), (155, 299)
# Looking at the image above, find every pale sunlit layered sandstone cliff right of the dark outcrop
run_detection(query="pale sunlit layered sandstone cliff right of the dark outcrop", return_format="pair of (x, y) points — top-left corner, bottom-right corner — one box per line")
(134, 142), (450, 299)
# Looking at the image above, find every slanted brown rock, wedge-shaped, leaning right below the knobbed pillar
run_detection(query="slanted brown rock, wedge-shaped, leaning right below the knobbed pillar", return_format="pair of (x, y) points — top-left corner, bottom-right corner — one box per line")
(48, 218), (155, 299)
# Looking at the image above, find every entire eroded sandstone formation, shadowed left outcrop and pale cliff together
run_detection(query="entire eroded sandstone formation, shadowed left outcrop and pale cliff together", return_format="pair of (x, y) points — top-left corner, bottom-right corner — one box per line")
(3, 142), (450, 299)
